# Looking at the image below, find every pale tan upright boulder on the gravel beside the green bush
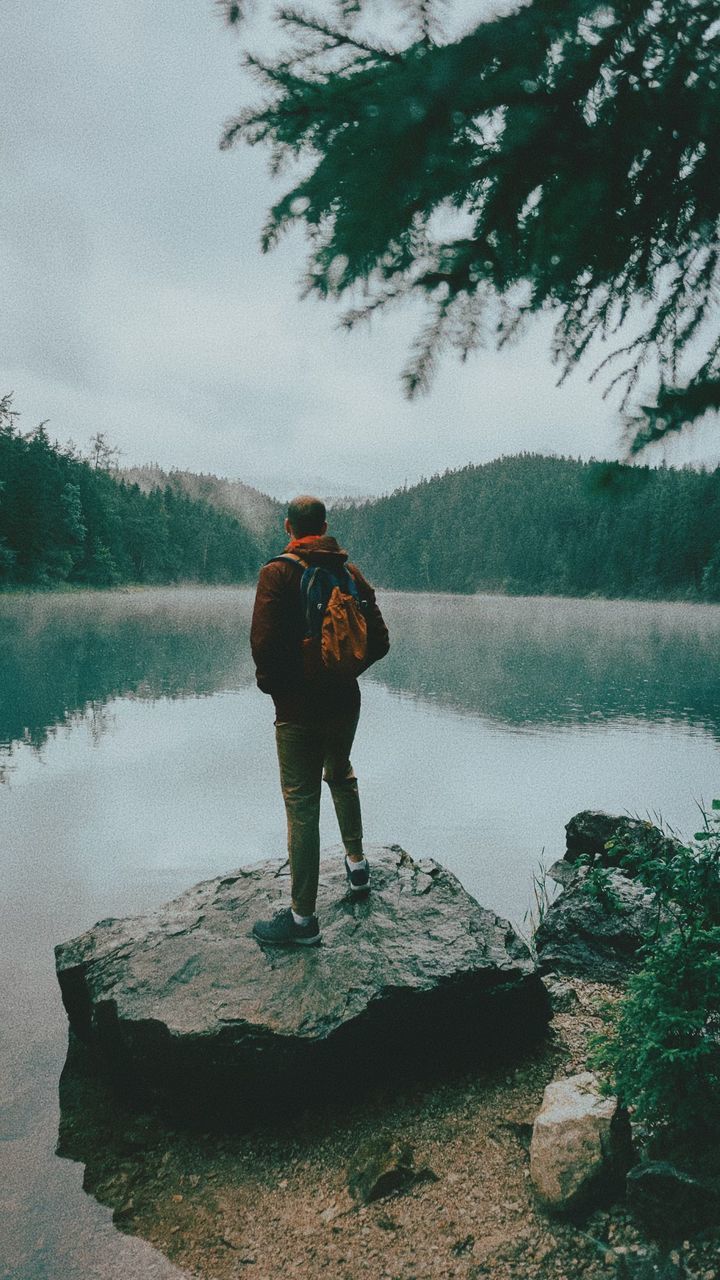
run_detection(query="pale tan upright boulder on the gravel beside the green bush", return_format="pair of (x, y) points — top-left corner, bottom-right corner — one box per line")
(530, 1071), (632, 1213)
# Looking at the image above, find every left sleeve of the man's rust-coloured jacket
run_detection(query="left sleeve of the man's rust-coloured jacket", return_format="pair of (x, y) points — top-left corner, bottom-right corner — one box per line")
(250, 563), (301, 694)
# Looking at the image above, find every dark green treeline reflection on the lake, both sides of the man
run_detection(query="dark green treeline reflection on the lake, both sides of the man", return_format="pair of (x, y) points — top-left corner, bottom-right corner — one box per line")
(0, 588), (720, 750)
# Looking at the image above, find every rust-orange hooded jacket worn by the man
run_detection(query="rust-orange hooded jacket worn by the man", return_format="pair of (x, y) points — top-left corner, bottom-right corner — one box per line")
(250, 535), (389, 724)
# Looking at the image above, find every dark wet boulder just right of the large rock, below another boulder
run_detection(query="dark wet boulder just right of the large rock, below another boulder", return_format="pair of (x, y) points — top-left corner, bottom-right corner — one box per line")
(534, 867), (657, 983)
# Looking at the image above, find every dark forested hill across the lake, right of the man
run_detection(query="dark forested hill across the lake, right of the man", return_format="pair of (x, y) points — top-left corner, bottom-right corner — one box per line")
(331, 453), (720, 600)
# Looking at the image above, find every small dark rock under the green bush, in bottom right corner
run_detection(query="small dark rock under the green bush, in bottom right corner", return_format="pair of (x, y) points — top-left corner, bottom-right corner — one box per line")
(626, 1160), (720, 1239)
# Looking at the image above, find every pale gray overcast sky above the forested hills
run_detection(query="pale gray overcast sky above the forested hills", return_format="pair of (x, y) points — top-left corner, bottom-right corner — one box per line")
(0, 0), (719, 497)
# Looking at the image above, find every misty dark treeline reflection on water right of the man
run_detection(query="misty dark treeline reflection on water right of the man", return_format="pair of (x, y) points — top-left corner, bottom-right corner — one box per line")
(375, 594), (720, 736)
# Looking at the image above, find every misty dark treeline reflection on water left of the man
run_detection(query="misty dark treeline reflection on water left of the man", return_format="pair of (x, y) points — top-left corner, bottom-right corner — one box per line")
(0, 588), (254, 751)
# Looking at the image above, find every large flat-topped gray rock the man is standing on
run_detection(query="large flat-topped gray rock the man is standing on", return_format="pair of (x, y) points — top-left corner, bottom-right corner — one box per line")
(56, 846), (550, 1117)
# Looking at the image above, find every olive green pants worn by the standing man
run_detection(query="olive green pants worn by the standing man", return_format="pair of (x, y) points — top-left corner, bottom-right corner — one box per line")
(275, 713), (363, 915)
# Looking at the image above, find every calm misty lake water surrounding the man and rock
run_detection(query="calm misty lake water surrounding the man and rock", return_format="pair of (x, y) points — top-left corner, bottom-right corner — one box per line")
(0, 589), (720, 1280)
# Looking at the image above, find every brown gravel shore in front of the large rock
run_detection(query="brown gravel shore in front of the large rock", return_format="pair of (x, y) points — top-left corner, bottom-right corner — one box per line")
(67, 980), (720, 1280)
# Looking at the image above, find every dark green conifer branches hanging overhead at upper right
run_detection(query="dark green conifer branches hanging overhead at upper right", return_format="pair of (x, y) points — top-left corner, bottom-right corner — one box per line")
(222, 0), (720, 451)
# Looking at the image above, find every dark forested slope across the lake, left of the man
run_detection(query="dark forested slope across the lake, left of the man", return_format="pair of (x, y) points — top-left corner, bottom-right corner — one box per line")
(0, 409), (265, 586)
